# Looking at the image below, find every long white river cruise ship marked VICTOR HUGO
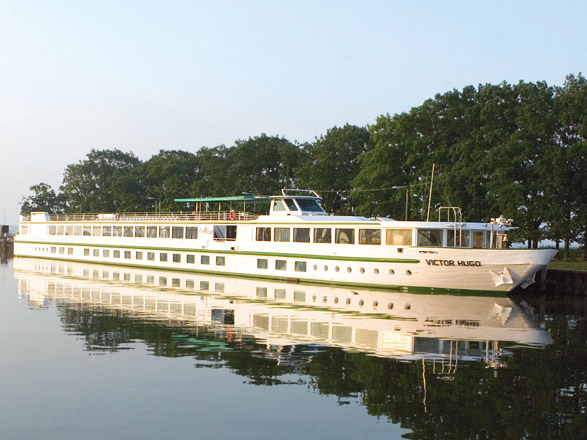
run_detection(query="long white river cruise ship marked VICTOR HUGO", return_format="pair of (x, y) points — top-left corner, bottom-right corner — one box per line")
(14, 191), (556, 293)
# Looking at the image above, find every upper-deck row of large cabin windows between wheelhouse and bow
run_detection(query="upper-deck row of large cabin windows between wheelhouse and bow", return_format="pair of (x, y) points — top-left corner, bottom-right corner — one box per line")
(256, 227), (412, 246)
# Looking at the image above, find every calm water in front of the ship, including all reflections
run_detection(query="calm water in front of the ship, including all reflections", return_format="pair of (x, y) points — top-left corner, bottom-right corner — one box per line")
(0, 260), (587, 439)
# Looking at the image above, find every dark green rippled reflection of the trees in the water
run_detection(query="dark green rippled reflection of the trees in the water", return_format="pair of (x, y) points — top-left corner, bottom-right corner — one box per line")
(54, 303), (587, 439)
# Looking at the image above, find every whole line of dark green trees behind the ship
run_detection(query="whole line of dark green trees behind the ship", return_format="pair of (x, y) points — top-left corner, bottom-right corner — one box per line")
(22, 74), (587, 254)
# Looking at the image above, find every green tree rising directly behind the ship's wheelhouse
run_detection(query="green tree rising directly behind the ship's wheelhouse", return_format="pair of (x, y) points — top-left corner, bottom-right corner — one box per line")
(296, 124), (373, 214)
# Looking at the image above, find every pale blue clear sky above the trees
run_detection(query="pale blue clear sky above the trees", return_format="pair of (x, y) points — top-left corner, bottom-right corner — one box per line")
(0, 0), (587, 225)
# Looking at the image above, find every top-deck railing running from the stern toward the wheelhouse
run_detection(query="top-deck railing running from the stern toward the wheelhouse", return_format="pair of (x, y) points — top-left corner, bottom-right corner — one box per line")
(42, 211), (259, 222)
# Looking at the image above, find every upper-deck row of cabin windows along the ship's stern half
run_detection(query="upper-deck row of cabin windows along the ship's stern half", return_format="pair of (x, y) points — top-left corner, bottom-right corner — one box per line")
(49, 225), (198, 239)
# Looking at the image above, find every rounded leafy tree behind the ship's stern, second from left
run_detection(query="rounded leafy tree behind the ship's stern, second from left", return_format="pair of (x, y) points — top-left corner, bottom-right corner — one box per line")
(61, 149), (144, 212)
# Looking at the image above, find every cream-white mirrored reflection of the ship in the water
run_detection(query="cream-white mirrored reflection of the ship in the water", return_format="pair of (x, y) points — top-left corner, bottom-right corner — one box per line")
(14, 258), (552, 367)
